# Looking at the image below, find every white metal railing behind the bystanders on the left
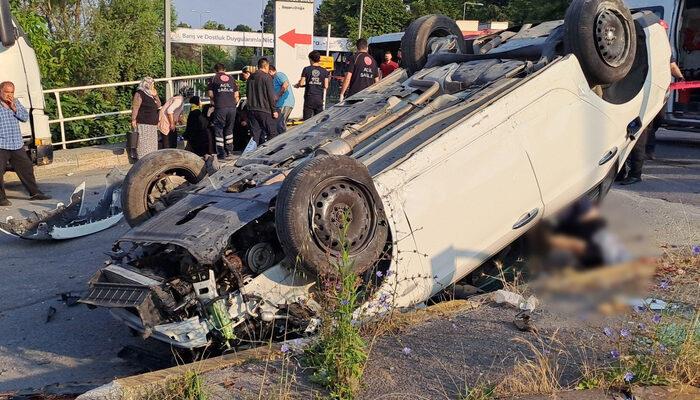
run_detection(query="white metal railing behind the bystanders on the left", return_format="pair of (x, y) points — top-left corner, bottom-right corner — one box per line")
(44, 71), (241, 149)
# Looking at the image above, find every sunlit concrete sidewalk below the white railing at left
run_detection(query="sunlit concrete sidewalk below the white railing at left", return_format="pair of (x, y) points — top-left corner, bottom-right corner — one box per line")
(5, 143), (129, 181)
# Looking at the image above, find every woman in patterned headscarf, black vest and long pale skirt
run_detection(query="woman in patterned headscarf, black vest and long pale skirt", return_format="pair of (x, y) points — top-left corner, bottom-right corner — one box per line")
(131, 77), (160, 159)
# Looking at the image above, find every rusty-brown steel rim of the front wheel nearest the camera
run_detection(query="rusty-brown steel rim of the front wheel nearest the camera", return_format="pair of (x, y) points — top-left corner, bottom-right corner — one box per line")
(309, 178), (376, 254)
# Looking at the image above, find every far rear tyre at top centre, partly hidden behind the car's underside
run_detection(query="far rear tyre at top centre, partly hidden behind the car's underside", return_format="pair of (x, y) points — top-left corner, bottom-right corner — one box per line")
(401, 14), (473, 74)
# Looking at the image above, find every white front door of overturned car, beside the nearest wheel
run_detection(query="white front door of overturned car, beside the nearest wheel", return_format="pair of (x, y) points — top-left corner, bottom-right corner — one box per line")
(375, 106), (543, 298)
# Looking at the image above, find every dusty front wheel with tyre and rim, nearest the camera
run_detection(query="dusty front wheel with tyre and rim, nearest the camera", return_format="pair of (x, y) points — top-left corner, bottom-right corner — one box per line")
(275, 155), (389, 277)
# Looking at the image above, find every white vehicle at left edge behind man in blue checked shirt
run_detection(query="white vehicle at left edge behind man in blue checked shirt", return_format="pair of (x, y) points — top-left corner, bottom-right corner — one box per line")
(0, 0), (53, 165)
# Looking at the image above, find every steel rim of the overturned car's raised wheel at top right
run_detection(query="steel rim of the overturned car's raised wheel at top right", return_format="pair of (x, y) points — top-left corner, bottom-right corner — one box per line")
(595, 10), (630, 68)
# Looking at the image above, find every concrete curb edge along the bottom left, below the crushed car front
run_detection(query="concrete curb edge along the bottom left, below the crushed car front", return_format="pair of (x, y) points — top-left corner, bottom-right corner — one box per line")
(76, 343), (281, 400)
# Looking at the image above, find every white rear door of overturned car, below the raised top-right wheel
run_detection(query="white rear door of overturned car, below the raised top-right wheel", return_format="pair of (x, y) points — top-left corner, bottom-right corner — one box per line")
(512, 81), (626, 216)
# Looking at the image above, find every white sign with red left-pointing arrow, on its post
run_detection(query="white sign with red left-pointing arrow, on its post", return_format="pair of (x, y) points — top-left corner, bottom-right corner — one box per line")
(275, 0), (314, 118)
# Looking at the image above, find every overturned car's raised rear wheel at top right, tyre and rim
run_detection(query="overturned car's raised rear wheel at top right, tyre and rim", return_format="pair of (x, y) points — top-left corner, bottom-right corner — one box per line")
(564, 0), (637, 86)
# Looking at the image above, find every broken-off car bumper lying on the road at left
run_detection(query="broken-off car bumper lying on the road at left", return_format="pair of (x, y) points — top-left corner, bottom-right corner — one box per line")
(0, 169), (124, 240)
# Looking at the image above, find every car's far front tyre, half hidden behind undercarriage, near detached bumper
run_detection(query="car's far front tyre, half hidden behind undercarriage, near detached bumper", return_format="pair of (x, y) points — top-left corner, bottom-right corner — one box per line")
(122, 149), (207, 228)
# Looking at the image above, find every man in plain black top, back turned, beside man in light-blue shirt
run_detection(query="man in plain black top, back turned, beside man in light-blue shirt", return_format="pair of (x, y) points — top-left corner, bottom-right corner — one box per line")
(247, 58), (278, 146)
